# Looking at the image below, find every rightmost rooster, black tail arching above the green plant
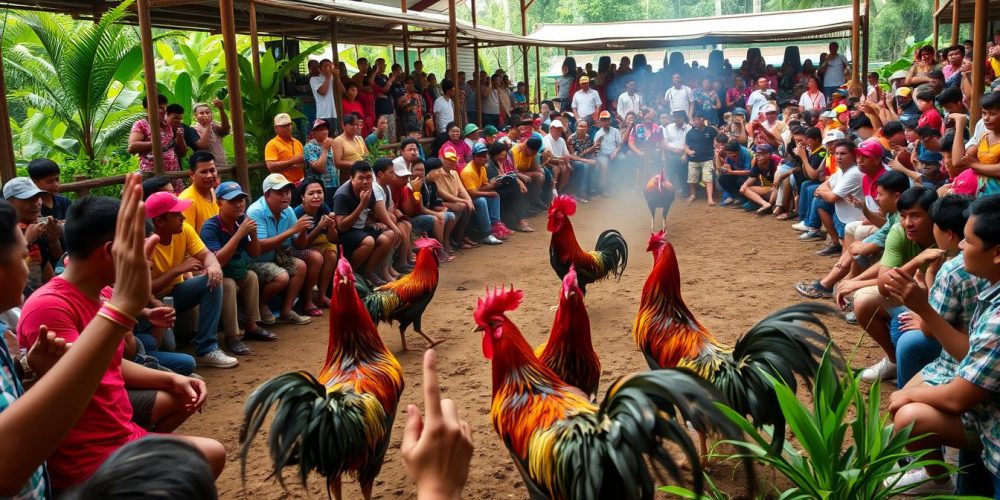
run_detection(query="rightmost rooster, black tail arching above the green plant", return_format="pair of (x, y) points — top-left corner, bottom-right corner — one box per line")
(632, 231), (840, 456)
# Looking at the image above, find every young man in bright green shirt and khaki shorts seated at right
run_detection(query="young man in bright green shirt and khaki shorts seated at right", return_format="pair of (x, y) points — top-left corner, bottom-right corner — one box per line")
(854, 186), (937, 382)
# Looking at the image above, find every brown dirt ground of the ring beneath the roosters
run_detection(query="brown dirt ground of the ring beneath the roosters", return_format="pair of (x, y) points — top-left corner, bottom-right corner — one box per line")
(186, 189), (887, 499)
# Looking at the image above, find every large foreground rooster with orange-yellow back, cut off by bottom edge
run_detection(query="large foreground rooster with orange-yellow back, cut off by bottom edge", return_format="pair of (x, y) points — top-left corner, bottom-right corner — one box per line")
(473, 286), (753, 499)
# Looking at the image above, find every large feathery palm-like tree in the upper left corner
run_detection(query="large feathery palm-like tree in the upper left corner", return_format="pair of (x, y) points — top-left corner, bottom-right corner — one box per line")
(3, 0), (172, 172)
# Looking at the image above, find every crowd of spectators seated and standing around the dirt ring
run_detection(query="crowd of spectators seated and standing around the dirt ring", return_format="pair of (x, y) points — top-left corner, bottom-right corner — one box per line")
(7, 33), (1000, 497)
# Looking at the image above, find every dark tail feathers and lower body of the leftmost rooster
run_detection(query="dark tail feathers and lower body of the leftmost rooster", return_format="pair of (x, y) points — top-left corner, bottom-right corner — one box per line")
(240, 371), (390, 487)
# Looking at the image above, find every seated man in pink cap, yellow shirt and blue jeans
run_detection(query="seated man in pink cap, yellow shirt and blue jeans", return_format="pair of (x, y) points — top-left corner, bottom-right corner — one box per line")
(144, 191), (239, 375)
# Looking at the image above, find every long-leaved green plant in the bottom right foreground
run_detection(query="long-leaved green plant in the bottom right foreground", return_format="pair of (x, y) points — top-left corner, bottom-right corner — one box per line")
(719, 353), (954, 499)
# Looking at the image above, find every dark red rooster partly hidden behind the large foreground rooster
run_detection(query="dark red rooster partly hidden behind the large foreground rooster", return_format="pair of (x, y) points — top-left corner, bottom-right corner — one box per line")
(535, 265), (601, 401)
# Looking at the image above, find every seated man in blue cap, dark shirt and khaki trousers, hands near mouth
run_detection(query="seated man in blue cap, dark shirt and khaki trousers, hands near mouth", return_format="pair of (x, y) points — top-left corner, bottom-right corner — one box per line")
(201, 181), (278, 356)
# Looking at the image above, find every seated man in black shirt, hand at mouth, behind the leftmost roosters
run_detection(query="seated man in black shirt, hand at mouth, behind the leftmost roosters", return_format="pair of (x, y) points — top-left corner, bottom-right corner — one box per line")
(333, 160), (396, 286)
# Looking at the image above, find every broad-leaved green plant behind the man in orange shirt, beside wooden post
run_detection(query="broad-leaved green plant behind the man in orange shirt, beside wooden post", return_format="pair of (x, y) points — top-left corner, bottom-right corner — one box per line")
(239, 44), (323, 161)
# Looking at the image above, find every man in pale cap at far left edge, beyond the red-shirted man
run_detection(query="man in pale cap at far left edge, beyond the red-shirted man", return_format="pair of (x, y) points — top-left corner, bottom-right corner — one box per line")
(3, 177), (63, 296)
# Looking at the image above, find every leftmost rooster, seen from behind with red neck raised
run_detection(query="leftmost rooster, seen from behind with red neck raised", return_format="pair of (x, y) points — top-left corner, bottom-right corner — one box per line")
(240, 257), (403, 500)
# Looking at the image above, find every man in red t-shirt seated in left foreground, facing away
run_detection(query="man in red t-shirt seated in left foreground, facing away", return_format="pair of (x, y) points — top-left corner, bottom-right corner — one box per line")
(17, 196), (226, 490)
